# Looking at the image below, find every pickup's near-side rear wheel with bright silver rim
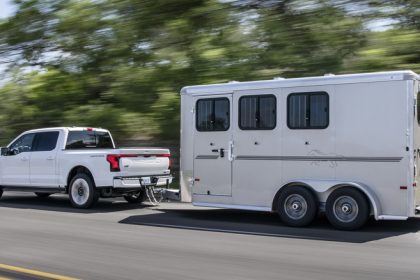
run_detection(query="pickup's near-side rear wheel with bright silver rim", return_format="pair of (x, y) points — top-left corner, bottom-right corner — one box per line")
(69, 173), (99, 209)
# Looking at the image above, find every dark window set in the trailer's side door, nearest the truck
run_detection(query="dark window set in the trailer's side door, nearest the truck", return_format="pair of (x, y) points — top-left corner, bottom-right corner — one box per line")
(196, 98), (230, 131)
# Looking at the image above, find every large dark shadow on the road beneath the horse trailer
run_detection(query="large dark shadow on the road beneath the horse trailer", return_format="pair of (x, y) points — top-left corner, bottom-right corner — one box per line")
(120, 209), (420, 243)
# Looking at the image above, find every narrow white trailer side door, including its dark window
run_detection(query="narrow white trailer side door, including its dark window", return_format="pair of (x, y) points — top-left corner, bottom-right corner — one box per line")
(193, 94), (232, 196)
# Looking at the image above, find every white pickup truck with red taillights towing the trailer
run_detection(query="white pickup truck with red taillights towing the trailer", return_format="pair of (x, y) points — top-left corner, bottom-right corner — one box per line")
(0, 127), (172, 208)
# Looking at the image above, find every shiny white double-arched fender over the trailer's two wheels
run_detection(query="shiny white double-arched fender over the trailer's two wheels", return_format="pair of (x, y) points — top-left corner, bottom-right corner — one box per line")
(273, 180), (382, 220)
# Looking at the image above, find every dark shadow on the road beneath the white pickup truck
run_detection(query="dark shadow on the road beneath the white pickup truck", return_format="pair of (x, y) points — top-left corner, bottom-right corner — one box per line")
(0, 193), (149, 214)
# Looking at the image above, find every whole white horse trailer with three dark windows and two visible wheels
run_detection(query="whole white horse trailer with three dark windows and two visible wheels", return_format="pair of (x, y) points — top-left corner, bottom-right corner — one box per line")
(180, 71), (420, 229)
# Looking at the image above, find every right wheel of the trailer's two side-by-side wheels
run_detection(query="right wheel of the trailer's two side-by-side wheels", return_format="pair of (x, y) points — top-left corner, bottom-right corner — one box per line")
(325, 187), (370, 230)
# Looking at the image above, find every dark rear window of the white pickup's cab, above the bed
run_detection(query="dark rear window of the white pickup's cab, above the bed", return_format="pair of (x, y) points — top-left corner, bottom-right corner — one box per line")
(66, 131), (114, 149)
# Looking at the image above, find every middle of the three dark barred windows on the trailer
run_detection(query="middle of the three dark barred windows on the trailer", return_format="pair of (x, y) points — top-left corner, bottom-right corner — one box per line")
(239, 95), (276, 130)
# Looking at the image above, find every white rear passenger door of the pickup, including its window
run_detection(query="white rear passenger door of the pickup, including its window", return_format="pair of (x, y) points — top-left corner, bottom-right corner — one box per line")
(30, 131), (59, 187)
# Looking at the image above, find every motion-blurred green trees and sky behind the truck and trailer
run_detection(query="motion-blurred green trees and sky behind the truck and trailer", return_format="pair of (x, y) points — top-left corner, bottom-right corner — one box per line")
(0, 0), (420, 179)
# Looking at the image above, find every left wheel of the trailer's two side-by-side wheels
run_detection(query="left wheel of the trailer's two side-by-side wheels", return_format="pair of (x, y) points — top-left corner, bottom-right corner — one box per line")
(277, 186), (318, 227)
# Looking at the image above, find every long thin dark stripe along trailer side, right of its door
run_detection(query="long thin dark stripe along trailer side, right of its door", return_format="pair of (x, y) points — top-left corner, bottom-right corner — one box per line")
(235, 155), (403, 162)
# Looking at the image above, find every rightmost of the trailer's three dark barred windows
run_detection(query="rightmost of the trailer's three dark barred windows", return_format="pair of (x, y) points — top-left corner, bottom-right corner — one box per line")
(287, 92), (329, 129)
